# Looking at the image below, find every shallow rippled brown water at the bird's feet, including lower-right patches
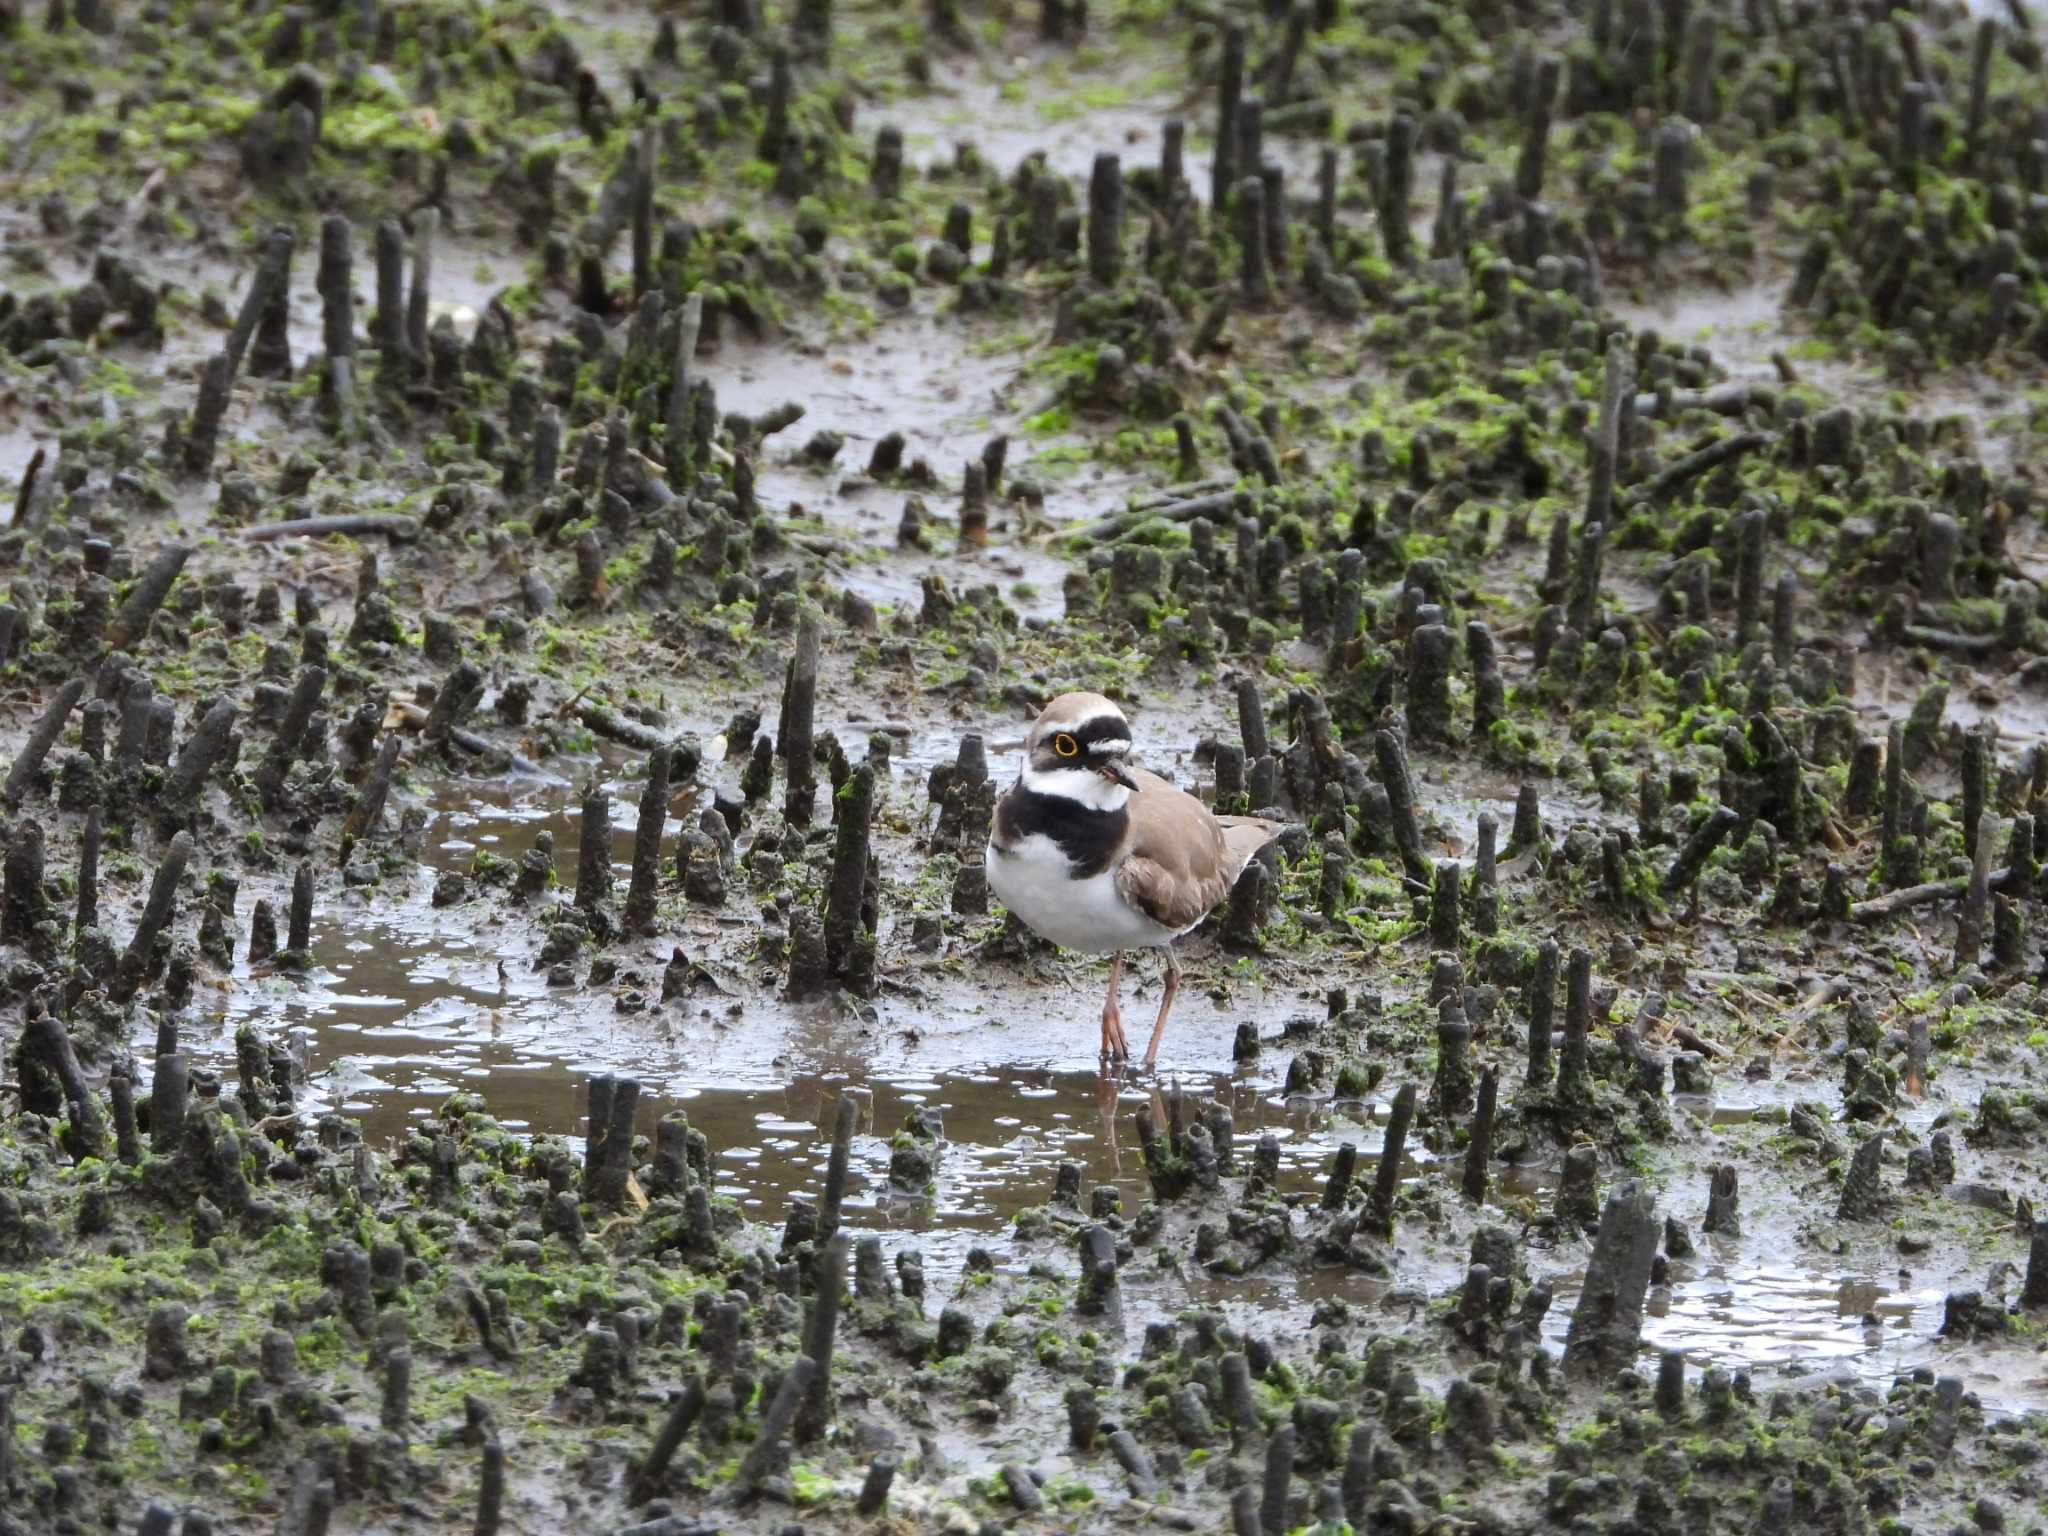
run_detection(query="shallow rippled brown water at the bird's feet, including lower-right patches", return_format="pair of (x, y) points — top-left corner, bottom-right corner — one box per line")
(172, 757), (2009, 1405)
